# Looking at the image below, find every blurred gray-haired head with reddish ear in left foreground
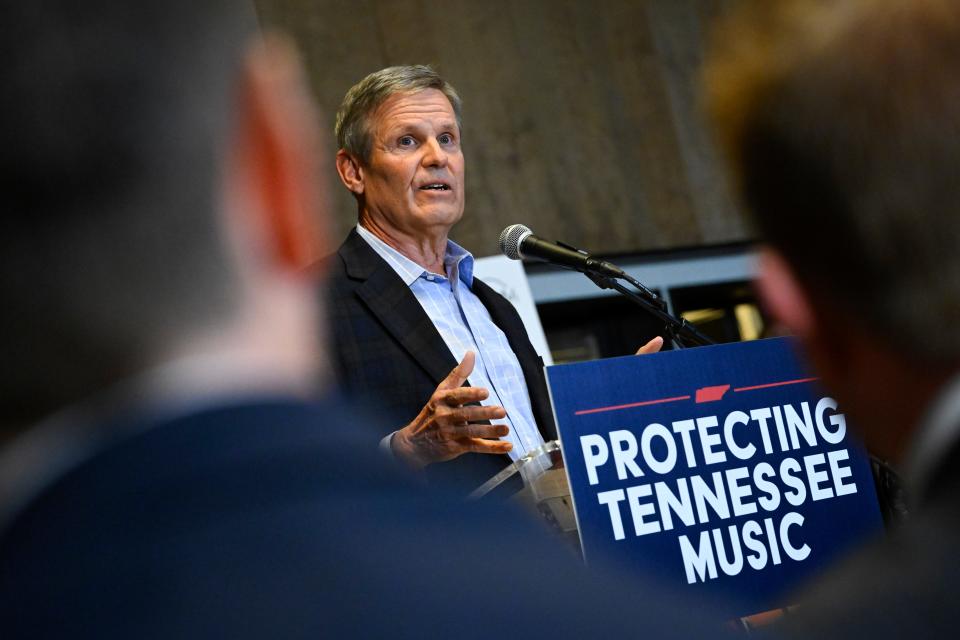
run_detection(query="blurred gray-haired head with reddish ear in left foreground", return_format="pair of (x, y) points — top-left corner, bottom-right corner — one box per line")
(0, 0), (321, 440)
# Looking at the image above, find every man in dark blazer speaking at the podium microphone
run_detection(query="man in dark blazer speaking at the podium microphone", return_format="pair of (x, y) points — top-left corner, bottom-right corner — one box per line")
(329, 66), (555, 490)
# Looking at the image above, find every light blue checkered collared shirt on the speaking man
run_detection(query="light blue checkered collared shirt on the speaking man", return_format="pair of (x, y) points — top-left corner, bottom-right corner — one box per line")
(357, 225), (543, 460)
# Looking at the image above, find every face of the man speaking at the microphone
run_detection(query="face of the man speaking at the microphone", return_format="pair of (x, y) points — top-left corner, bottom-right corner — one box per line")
(362, 89), (464, 237)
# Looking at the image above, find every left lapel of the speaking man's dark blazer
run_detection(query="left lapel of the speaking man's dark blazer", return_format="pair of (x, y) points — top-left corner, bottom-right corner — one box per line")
(339, 229), (457, 384)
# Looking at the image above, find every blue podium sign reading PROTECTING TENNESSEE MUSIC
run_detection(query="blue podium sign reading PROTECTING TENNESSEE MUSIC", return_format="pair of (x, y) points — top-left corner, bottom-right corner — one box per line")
(547, 338), (882, 616)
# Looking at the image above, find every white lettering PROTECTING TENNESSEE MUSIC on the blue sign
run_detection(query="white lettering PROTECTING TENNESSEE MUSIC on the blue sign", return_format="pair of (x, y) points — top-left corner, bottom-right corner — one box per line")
(580, 398), (857, 584)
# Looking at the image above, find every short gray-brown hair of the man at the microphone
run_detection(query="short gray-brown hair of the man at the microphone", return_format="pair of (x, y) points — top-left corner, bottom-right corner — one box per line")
(334, 64), (463, 164)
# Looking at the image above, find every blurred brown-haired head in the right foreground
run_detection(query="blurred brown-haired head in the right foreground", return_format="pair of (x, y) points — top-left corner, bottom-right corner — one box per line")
(706, 0), (960, 461)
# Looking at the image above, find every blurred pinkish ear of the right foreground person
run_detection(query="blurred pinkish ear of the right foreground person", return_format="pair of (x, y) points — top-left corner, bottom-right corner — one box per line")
(756, 247), (817, 341)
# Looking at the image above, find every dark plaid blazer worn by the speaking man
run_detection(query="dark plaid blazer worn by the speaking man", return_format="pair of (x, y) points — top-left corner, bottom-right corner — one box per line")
(326, 229), (556, 490)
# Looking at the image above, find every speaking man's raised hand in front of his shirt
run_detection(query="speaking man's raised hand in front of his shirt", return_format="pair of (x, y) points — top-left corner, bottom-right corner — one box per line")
(390, 351), (513, 469)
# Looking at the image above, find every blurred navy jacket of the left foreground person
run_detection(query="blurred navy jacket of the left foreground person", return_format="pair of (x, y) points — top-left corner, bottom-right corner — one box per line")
(0, 399), (714, 640)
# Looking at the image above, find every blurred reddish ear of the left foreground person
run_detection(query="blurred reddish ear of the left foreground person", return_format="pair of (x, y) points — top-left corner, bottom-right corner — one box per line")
(226, 36), (329, 272)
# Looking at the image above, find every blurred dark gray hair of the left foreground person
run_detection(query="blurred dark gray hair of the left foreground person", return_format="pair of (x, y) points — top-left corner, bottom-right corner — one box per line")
(0, 0), (256, 430)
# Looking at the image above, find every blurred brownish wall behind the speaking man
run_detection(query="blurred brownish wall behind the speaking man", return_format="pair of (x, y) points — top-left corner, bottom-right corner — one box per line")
(255, 0), (748, 255)
